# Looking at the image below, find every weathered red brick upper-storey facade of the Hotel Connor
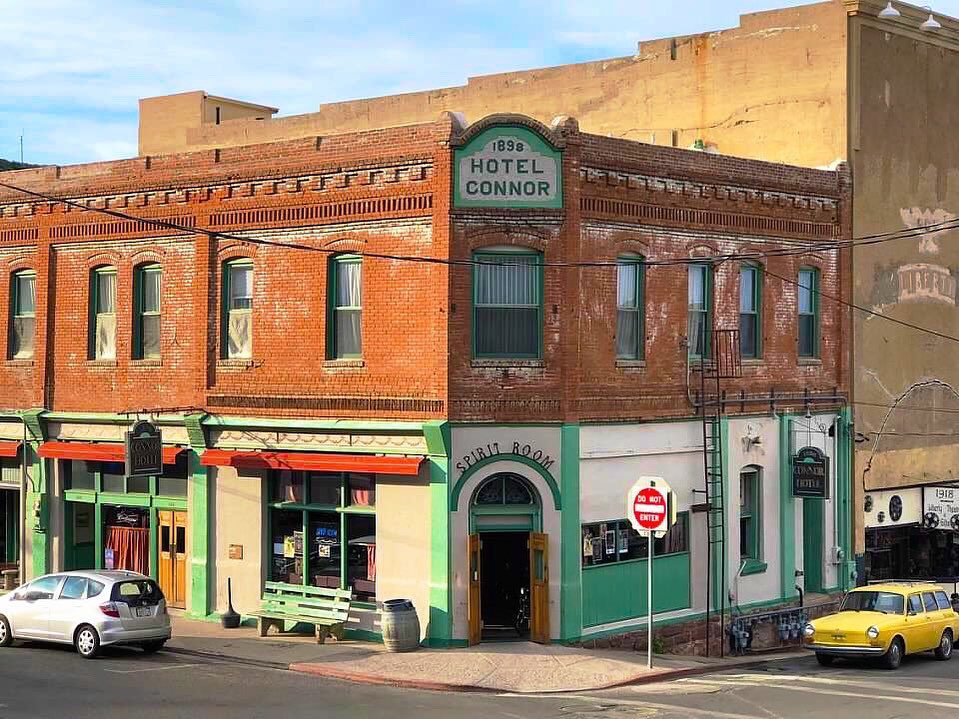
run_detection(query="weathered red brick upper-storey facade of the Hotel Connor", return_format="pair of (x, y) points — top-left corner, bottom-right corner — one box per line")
(0, 115), (850, 422)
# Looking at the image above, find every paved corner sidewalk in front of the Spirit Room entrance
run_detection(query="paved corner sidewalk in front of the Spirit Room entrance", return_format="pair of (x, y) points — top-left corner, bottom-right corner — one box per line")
(167, 616), (796, 693)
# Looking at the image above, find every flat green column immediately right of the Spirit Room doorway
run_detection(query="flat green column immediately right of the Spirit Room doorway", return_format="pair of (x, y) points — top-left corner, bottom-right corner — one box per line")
(560, 424), (583, 642)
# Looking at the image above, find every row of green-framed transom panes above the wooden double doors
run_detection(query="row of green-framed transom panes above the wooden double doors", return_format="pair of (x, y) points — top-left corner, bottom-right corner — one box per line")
(63, 452), (188, 497)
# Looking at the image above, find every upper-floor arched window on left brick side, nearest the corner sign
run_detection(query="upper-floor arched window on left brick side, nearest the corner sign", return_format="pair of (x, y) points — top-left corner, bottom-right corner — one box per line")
(326, 255), (363, 359)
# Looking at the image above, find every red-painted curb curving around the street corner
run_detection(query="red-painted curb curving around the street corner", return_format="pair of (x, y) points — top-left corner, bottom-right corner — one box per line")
(288, 652), (802, 694)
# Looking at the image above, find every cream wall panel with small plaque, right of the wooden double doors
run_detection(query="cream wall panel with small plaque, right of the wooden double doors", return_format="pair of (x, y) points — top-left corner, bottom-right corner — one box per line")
(210, 467), (267, 614)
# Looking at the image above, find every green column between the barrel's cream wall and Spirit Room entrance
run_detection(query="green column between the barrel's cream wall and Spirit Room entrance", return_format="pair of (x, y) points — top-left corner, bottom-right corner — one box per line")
(423, 422), (453, 647)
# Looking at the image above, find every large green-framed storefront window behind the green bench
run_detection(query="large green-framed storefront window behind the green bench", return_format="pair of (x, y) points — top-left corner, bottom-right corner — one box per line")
(268, 470), (376, 602)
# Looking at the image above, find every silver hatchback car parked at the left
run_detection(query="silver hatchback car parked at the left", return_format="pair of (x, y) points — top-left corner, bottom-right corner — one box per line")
(0, 570), (170, 659)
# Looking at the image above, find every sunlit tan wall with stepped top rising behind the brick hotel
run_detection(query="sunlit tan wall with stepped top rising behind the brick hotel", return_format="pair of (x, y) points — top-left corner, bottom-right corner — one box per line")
(152, 0), (846, 167)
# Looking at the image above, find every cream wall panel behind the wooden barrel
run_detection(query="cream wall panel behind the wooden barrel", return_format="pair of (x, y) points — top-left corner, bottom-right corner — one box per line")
(376, 472), (431, 638)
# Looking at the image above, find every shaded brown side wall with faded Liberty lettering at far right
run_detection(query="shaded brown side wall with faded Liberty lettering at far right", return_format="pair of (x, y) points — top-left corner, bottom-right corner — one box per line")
(850, 15), (959, 553)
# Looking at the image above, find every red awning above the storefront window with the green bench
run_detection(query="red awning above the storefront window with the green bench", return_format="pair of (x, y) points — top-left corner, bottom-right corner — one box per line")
(200, 449), (423, 477)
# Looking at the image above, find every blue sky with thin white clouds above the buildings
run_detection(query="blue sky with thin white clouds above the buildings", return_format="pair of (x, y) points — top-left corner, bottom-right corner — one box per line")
(0, 0), (959, 165)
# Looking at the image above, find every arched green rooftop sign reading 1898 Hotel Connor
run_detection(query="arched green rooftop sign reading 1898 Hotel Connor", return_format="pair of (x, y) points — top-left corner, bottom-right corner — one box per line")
(453, 126), (563, 208)
